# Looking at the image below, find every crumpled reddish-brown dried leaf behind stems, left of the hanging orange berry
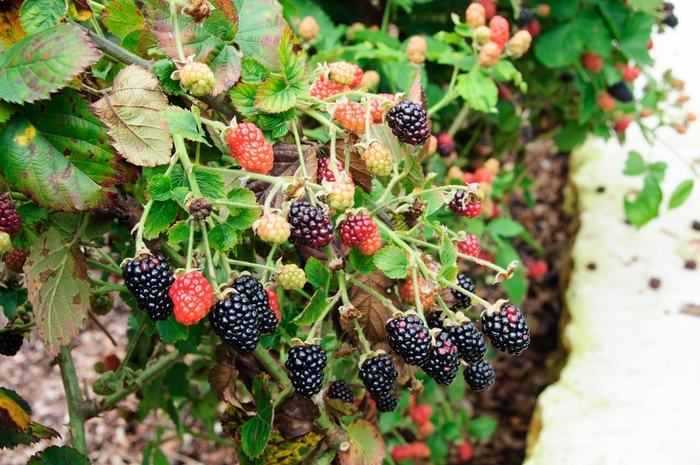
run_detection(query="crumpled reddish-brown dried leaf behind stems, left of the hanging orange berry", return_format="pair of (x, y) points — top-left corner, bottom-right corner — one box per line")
(341, 271), (399, 342)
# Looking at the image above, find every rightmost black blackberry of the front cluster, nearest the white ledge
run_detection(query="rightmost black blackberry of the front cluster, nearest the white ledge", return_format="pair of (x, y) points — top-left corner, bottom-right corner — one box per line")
(481, 304), (530, 355)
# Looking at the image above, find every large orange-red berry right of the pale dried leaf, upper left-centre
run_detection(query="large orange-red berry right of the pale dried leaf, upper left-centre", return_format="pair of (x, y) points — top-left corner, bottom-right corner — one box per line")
(228, 123), (275, 174)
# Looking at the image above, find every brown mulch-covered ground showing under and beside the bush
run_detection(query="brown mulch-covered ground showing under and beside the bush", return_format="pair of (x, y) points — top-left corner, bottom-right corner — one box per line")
(0, 144), (576, 465)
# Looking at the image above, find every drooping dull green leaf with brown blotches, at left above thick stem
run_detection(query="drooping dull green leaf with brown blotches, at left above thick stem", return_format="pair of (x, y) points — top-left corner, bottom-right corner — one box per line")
(24, 228), (90, 355)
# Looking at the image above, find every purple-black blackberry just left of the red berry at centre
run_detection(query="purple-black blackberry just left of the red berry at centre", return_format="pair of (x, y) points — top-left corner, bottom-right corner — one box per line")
(287, 200), (335, 248)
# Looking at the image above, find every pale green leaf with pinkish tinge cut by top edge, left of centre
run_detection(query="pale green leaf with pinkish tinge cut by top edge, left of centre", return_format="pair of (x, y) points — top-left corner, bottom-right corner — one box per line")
(236, 0), (287, 71)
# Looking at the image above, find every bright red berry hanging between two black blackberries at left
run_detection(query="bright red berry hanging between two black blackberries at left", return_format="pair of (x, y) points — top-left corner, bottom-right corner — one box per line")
(168, 271), (214, 326)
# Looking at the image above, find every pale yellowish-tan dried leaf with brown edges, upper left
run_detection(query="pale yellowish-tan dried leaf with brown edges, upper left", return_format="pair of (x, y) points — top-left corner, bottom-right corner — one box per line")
(93, 65), (173, 167)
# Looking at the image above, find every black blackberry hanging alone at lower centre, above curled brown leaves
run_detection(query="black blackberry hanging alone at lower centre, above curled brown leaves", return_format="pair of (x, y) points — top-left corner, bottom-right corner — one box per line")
(286, 344), (327, 397)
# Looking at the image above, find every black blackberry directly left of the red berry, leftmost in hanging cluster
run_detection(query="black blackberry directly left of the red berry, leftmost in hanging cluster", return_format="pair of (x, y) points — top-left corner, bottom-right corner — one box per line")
(122, 255), (175, 321)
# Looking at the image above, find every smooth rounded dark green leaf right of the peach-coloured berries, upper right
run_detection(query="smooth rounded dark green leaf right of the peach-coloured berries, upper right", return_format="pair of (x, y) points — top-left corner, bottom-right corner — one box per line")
(535, 21), (586, 69)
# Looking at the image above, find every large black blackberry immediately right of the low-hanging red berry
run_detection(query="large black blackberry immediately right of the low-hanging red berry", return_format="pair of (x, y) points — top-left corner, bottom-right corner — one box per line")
(209, 292), (260, 352)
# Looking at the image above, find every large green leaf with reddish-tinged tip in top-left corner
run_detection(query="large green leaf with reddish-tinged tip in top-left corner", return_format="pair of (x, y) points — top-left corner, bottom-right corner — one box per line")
(0, 24), (100, 103)
